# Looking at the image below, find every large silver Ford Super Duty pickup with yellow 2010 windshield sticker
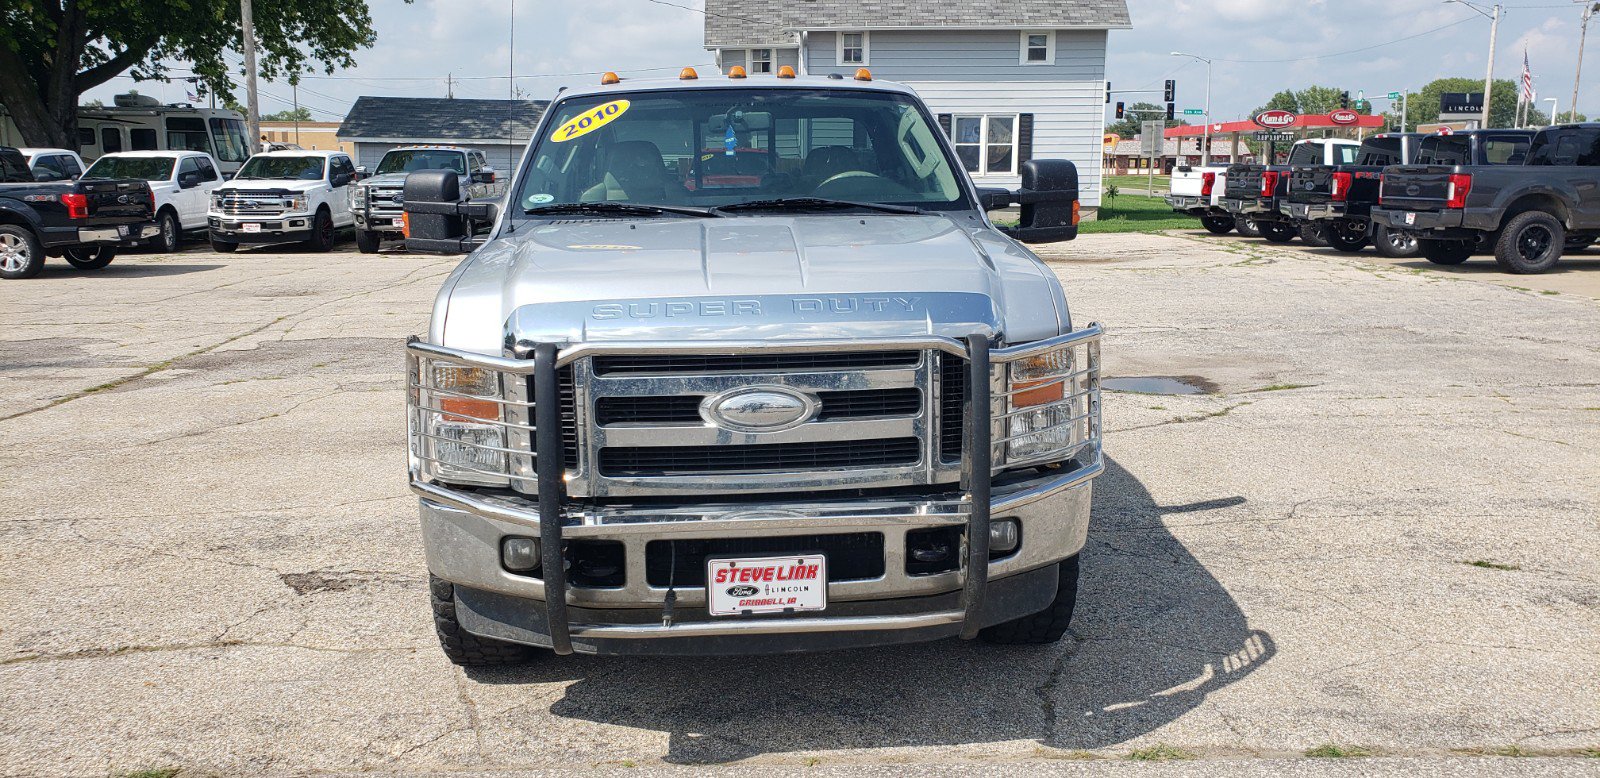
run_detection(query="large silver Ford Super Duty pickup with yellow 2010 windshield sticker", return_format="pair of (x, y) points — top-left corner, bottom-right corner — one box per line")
(405, 69), (1104, 664)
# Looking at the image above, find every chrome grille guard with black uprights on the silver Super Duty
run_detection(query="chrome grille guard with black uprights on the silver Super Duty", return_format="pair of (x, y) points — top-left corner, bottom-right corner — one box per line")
(406, 323), (1104, 655)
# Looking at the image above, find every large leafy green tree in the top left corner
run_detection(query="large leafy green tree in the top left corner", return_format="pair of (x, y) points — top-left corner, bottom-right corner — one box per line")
(0, 0), (398, 149)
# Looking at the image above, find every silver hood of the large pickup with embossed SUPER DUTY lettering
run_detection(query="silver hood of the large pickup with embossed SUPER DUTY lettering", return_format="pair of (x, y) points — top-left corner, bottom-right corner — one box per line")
(430, 215), (1067, 354)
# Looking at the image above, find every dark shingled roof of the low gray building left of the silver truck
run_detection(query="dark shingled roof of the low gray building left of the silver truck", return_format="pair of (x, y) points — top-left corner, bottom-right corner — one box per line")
(338, 96), (550, 141)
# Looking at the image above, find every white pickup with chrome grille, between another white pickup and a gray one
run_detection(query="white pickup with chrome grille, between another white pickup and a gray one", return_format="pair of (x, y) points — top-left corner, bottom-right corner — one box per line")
(206, 150), (355, 251)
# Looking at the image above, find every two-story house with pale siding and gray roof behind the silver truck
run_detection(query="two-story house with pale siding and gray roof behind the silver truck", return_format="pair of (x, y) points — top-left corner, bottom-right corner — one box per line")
(706, 0), (1133, 208)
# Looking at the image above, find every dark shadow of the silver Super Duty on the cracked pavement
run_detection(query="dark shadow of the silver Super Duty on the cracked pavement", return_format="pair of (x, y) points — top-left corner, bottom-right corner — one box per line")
(469, 461), (1275, 764)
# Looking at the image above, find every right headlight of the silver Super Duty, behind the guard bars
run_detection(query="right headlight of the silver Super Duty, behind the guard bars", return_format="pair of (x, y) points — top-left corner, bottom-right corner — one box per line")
(1002, 347), (1088, 464)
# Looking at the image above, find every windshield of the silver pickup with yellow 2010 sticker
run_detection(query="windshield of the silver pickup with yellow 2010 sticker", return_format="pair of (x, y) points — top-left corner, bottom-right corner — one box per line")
(517, 90), (970, 210)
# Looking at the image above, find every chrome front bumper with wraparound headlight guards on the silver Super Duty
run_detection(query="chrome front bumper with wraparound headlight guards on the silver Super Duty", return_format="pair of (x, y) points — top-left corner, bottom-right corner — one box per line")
(410, 325), (1104, 653)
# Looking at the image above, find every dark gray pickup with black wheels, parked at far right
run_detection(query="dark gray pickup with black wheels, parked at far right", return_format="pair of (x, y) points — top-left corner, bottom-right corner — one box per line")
(1373, 123), (1600, 274)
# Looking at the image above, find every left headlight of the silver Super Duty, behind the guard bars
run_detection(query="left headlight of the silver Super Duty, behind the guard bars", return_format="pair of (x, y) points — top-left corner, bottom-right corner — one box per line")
(414, 362), (509, 483)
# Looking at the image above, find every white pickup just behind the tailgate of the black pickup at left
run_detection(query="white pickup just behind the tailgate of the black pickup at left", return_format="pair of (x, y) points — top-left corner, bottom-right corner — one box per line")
(83, 150), (222, 253)
